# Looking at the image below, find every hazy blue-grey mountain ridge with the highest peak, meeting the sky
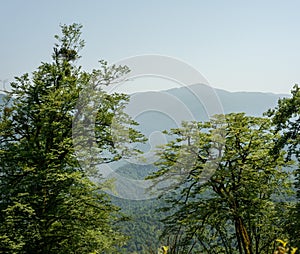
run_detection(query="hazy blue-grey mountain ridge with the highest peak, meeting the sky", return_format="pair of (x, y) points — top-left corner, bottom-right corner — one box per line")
(127, 84), (289, 135)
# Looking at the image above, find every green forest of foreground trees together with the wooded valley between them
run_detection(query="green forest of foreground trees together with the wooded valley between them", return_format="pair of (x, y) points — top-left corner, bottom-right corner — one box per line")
(0, 24), (300, 254)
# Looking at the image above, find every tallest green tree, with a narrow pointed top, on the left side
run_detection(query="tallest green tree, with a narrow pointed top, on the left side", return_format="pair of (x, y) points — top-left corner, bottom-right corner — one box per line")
(0, 24), (143, 254)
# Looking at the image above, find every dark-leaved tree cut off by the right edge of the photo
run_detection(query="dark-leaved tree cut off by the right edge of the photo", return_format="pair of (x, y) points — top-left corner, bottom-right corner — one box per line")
(268, 85), (300, 246)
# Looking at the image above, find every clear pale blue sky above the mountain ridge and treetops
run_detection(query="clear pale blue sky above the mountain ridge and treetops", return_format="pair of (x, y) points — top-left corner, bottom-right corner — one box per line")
(0, 0), (300, 94)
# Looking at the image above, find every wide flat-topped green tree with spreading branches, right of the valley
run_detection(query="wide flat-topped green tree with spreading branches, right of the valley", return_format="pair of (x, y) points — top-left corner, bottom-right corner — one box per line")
(149, 113), (290, 254)
